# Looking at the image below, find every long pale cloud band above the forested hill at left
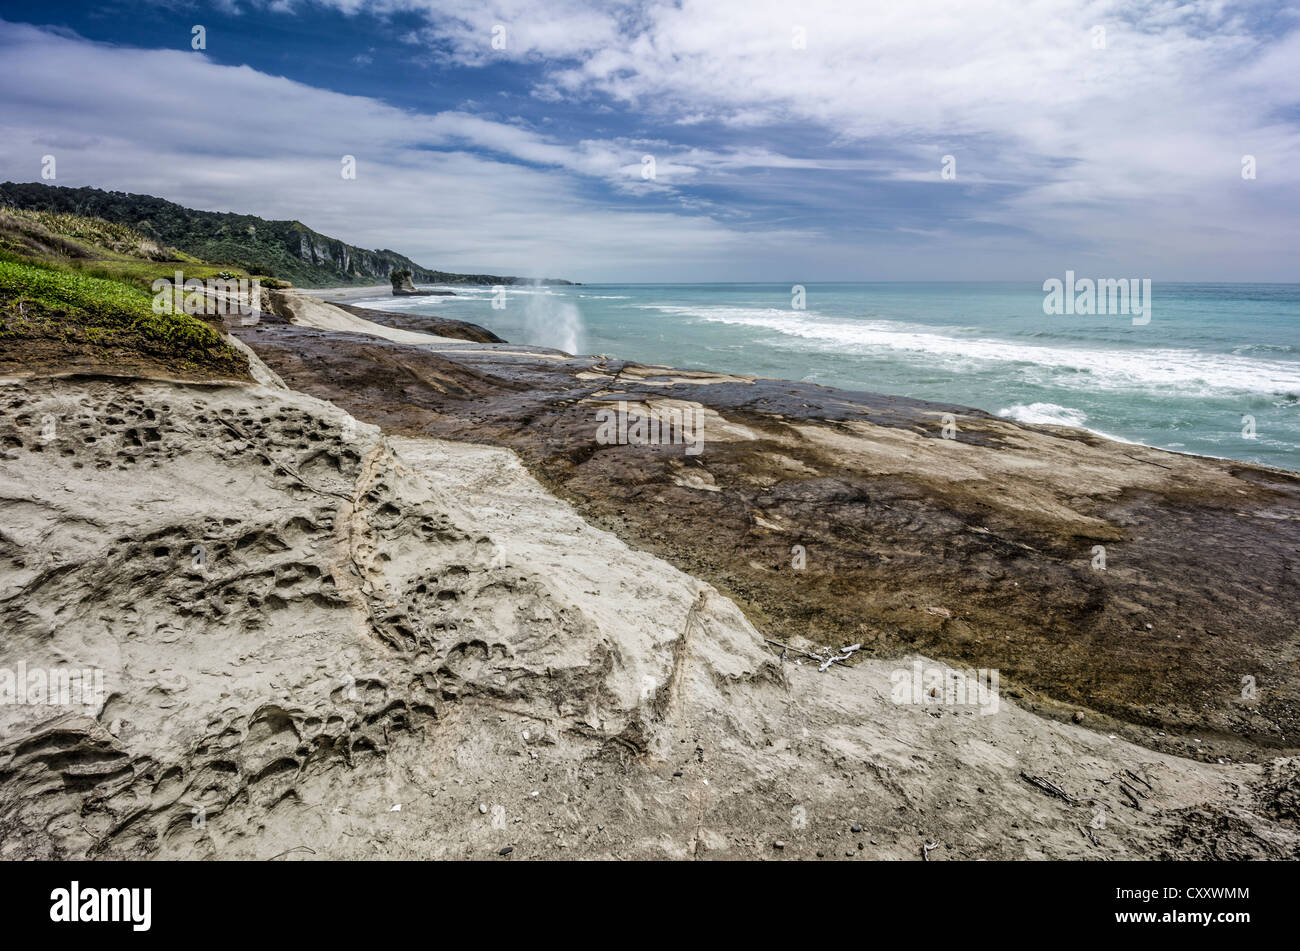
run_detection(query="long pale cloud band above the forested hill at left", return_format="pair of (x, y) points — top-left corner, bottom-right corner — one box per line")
(0, 23), (810, 281)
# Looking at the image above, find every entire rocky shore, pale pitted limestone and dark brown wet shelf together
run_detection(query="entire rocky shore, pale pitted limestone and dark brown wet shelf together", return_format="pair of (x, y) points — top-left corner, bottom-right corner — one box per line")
(0, 285), (1300, 861)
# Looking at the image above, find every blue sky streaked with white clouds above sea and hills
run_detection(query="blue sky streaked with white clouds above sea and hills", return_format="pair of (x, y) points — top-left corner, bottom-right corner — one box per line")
(0, 0), (1300, 283)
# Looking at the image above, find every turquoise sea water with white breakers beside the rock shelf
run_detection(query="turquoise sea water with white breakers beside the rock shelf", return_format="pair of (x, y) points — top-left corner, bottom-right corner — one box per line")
(358, 284), (1300, 469)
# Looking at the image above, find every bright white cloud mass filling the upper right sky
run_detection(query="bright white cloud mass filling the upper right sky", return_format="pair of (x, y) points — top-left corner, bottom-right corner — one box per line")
(297, 0), (1300, 273)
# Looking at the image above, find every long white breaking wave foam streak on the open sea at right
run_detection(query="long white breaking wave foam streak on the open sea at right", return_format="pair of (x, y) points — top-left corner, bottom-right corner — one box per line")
(644, 305), (1300, 396)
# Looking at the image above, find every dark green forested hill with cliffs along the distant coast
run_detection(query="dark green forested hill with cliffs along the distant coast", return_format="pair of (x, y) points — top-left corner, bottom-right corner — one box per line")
(0, 182), (579, 287)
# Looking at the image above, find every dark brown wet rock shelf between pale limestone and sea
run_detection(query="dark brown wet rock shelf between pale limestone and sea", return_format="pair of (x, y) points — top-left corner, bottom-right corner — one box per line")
(243, 297), (1300, 760)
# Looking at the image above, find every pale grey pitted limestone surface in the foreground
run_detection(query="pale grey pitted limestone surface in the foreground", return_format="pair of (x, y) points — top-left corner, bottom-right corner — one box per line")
(0, 379), (1300, 860)
